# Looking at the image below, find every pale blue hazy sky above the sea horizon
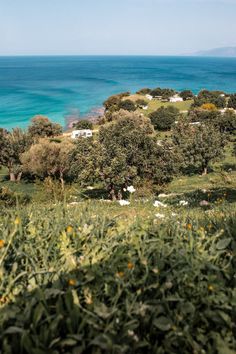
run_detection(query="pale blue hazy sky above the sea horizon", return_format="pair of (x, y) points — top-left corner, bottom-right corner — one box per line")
(0, 0), (236, 55)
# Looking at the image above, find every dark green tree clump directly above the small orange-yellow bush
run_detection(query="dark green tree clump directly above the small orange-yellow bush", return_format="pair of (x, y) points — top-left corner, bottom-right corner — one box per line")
(193, 90), (226, 108)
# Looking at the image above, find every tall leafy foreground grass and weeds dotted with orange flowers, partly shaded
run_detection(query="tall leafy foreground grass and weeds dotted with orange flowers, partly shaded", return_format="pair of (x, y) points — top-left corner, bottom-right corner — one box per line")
(0, 203), (236, 354)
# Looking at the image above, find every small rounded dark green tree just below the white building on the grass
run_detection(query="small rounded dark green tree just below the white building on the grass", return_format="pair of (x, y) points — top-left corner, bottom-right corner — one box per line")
(149, 106), (179, 131)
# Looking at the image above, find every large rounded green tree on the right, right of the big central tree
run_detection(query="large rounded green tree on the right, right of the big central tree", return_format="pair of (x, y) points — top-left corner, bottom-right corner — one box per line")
(172, 119), (226, 173)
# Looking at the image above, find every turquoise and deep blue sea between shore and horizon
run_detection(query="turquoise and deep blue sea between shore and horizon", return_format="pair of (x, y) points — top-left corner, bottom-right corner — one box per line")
(0, 56), (236, 129)
